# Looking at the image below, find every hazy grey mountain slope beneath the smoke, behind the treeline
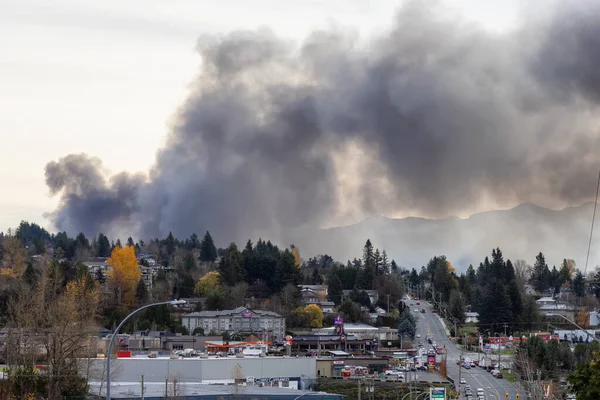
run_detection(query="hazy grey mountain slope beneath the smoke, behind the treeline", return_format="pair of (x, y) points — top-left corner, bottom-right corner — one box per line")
(291, 203), (600, 270)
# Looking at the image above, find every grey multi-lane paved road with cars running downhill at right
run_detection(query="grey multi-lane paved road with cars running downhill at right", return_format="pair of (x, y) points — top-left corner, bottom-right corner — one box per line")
(405, 300), (525, 400)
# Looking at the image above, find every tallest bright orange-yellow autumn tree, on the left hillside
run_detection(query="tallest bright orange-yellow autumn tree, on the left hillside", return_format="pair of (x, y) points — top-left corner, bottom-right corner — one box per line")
(106, 246), (142, 307)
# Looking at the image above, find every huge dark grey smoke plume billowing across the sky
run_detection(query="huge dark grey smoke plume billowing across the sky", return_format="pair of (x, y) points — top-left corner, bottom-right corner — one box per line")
(46, 1), (600, 244)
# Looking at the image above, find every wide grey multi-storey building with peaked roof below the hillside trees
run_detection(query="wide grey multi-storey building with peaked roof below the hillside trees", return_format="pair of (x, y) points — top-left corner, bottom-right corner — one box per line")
(181, 307), (285, 341)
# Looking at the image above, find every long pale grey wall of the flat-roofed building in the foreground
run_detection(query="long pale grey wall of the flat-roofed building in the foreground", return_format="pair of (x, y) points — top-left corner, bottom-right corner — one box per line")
(90, 357), (317, 382)
